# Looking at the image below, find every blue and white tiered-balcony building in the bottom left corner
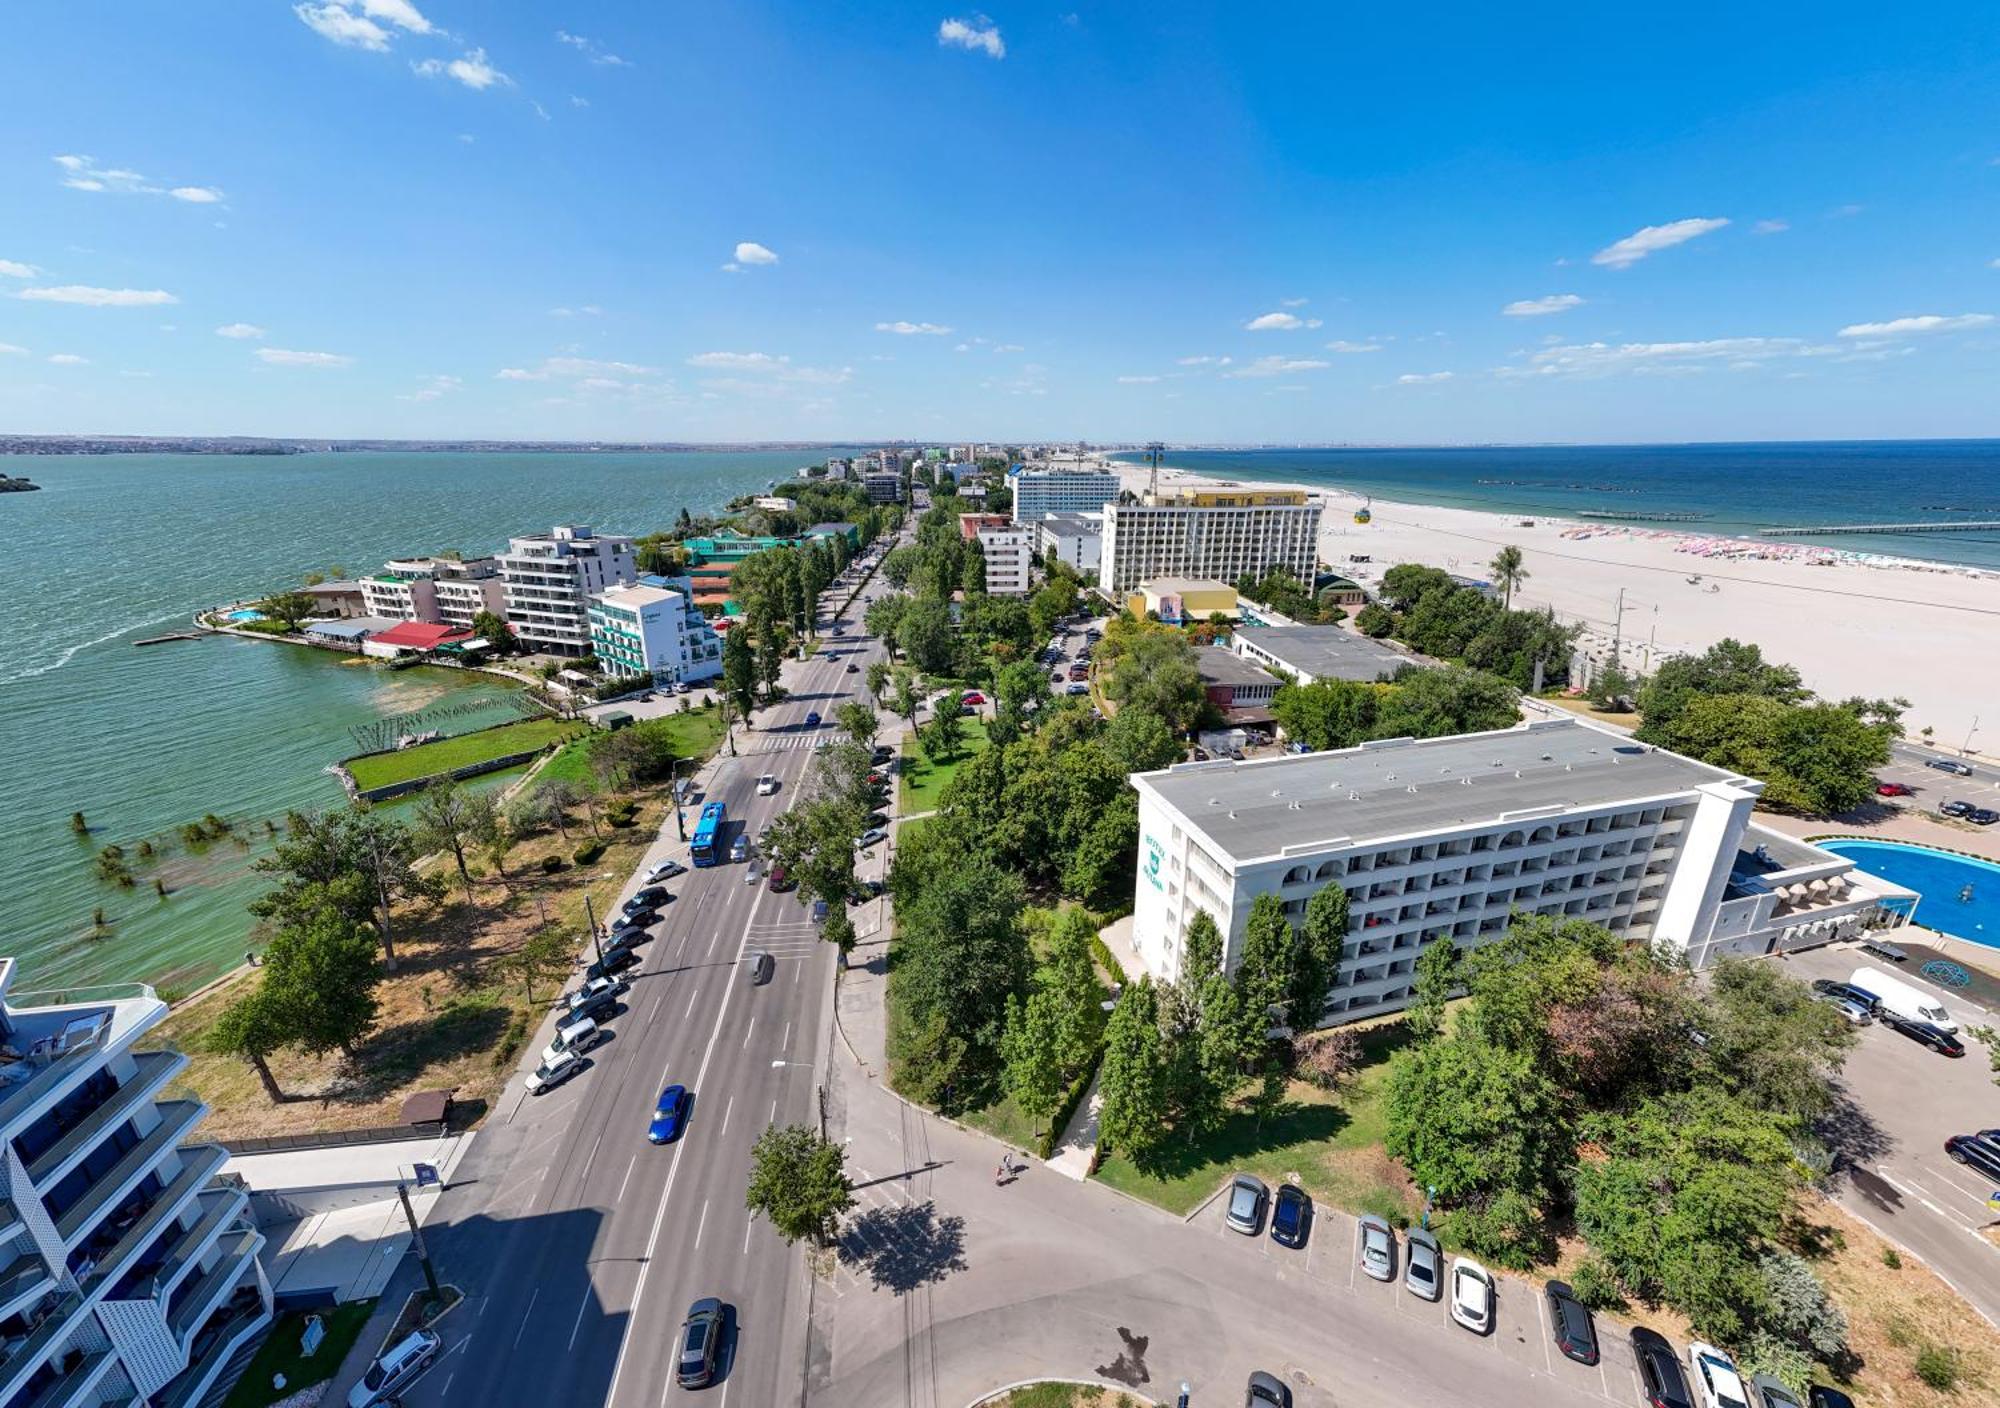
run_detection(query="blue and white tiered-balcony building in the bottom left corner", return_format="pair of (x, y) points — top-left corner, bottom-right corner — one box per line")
(0, 958), (272, 1408)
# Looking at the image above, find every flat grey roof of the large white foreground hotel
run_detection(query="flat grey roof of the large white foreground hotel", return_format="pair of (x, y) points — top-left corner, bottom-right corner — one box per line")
(1132, 718), (1762, 864)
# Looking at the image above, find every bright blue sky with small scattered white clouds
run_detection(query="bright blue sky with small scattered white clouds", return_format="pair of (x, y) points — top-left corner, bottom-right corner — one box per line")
(0, 0), (2000, 442)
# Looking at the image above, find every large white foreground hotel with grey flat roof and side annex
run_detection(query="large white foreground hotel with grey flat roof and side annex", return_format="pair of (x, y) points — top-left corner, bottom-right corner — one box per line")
(1132, 720), (1916, 1024)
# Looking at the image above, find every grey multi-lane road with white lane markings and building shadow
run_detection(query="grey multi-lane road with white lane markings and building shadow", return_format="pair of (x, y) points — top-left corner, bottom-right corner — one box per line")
(390, 556), (880, 1408)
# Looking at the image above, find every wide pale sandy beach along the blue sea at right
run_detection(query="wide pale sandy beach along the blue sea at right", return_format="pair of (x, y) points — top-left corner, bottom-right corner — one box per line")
(1112, 464), (2000, 752)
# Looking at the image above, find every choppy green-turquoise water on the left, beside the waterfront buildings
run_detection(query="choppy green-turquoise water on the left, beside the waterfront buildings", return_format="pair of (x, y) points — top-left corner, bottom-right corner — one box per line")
(0, 450), (844, 988)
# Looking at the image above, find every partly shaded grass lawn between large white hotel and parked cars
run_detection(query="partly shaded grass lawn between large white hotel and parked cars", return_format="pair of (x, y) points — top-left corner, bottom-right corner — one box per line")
(1096, 1024), (1422, 1222)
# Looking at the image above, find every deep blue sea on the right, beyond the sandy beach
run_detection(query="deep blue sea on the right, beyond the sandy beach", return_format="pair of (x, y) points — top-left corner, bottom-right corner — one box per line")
(1118, 440), (2000, 568)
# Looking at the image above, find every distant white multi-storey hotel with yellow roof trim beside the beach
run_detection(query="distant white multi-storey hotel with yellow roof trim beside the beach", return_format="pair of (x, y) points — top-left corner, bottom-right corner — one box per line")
(1096, 490), (1320, 600)
